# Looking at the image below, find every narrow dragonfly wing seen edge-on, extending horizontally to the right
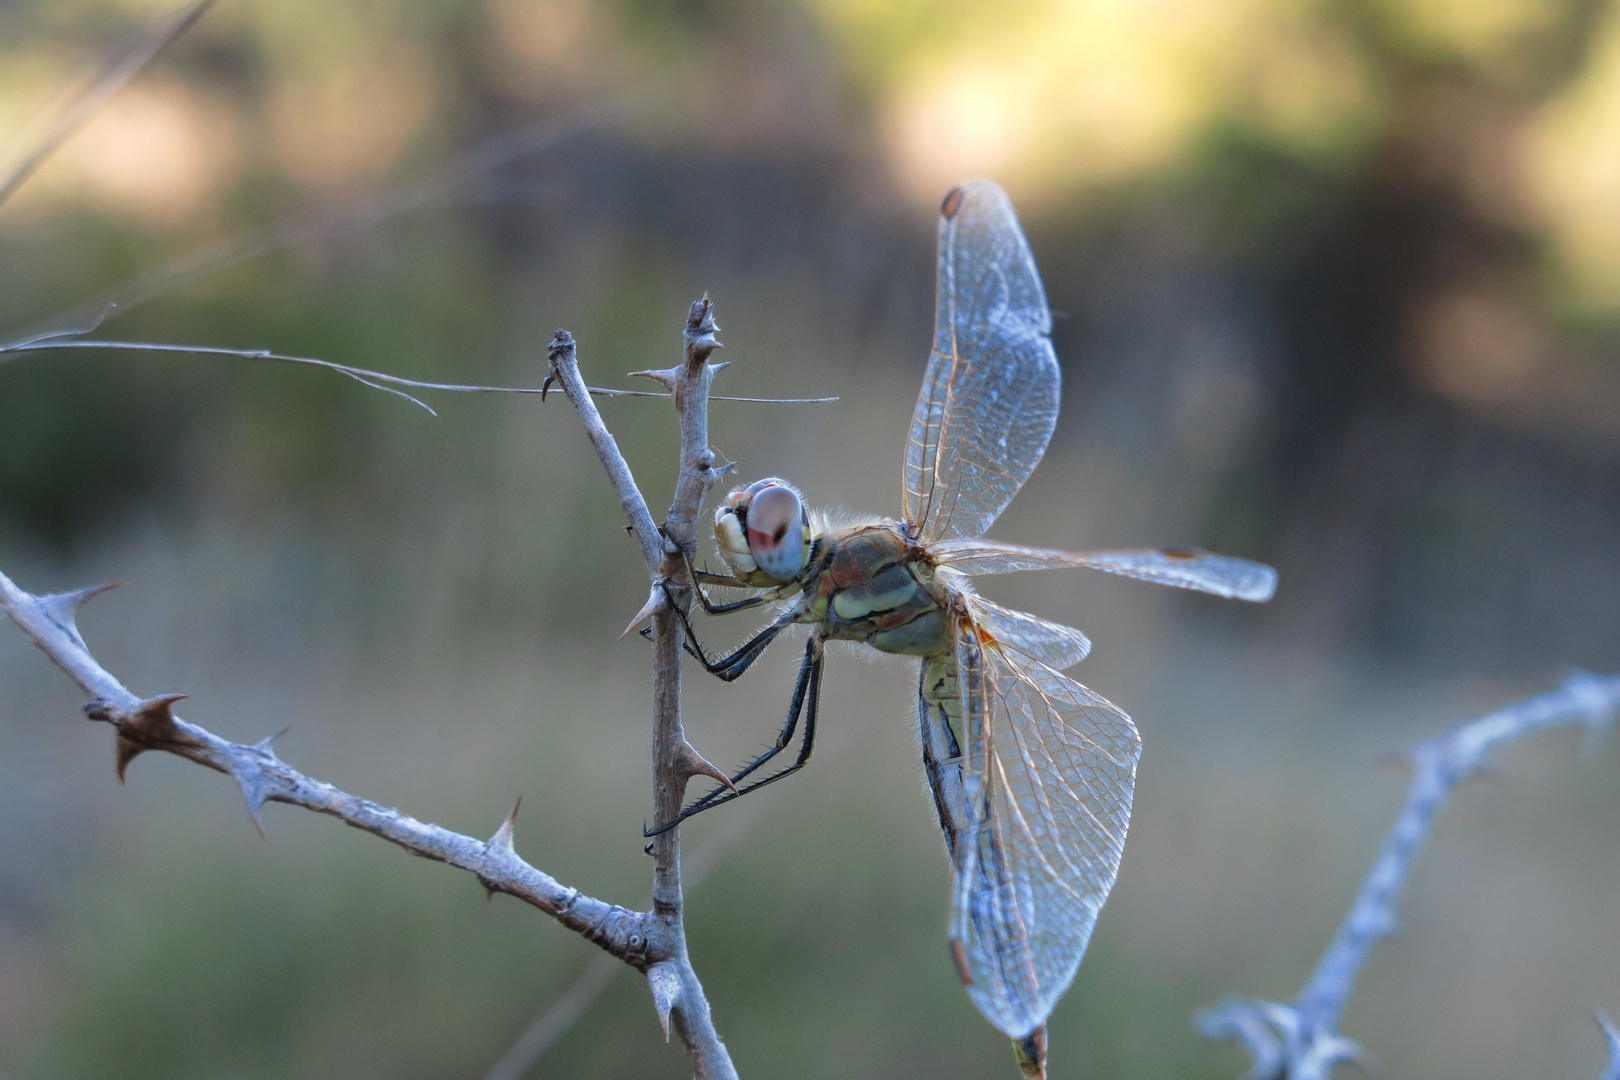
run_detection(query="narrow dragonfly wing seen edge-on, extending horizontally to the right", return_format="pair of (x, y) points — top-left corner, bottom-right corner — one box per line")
(928, 538), (1277, 602)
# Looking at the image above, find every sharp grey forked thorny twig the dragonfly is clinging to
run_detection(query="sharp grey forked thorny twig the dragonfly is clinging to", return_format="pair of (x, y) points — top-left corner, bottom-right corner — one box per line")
(0, 296), (737, 1080)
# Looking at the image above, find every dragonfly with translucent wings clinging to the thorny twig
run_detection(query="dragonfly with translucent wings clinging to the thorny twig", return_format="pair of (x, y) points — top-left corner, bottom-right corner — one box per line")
(648, 181), (1277, 1077)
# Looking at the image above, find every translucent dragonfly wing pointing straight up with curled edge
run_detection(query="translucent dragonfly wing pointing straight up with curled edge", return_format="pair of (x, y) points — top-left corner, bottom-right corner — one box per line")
(904, 180), (1059, 542)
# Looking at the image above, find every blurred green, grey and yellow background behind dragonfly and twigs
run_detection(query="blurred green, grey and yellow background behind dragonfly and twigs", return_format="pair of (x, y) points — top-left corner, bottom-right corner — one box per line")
(0, 0), (1620, 1080)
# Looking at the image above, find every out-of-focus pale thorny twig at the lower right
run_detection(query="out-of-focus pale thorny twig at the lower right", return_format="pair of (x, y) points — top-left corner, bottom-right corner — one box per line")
(1196, 672), (1620, 1080)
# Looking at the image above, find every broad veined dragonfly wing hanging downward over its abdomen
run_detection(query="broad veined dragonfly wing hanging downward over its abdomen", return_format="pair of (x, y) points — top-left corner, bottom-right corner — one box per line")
(920, 623), (1142, 1040)
